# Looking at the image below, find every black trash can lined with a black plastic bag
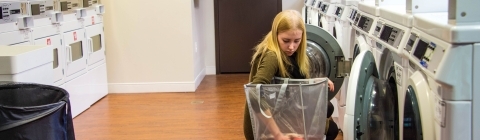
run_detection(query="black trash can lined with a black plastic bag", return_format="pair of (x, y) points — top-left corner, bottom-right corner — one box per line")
(0, 83), (75, 140)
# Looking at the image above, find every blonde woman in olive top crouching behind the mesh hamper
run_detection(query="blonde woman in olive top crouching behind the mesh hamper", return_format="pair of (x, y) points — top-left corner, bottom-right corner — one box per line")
(244, 10), (336, 140)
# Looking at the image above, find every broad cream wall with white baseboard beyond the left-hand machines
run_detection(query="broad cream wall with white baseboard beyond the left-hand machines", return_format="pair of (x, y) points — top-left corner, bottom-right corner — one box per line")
(102, 0), (204, 93)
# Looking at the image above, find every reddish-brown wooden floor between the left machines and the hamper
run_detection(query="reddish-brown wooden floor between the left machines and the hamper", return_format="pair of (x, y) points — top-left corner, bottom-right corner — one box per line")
(73, 74), (341, 140)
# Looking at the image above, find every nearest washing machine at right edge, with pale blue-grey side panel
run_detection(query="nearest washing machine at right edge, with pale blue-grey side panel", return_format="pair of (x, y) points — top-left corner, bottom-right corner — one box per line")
(404, 9), (480, 140)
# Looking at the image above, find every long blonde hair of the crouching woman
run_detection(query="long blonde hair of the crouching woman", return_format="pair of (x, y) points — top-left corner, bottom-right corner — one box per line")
(251, 10), (310, 78)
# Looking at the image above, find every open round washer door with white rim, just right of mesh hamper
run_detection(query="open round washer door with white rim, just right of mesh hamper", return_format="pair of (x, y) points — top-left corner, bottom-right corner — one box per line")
(347, 51), (399, 140)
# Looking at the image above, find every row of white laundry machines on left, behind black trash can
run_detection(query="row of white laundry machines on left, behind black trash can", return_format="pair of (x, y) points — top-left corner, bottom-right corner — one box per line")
(0, 0), (108, 117)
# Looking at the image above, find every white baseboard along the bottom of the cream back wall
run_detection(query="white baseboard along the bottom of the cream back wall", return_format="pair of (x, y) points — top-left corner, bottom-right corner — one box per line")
(108, 69), (205, 93)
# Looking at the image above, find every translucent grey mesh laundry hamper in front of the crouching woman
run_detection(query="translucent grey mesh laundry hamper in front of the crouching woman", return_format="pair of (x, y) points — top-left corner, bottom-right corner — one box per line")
(244, 78), (328, 140)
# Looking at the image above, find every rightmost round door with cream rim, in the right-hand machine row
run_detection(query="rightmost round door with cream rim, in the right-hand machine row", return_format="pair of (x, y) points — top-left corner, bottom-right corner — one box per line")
(400, 71), (435, 140)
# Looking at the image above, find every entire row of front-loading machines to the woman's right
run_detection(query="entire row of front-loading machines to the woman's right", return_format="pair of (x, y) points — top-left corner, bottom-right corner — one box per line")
(302, 0), (480, 140)
